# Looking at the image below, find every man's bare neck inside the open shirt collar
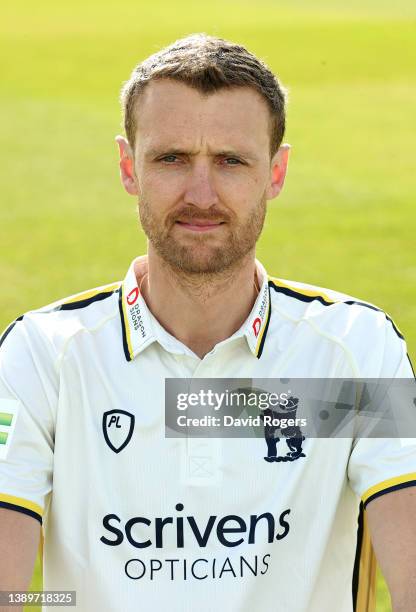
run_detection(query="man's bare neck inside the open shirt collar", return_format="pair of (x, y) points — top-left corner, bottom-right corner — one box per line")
(136, 252), (258, 359)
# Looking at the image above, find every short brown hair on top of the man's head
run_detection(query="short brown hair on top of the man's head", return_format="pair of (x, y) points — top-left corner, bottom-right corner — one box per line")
(120, 34), (286, 156)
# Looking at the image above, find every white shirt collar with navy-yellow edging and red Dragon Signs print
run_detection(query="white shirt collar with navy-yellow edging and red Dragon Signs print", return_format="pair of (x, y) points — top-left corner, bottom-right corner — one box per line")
(119, 255), (271, 361)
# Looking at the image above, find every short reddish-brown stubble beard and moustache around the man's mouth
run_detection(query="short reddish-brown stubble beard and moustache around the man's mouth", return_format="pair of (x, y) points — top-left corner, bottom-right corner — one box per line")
(138, 194), (267, 279)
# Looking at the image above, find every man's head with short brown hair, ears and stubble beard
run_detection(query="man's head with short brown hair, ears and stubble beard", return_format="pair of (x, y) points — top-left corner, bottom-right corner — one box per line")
(117, 35), (288, 274)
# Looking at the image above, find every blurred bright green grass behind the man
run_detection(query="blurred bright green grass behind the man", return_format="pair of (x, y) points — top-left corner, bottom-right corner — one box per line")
(0, 0), (416, 612)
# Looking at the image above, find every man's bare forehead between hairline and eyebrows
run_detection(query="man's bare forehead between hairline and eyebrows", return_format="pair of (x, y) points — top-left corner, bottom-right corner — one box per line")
(136, 79), (270, 154)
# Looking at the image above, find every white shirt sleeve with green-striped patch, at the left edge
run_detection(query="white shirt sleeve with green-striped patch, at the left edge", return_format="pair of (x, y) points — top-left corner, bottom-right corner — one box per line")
(0, 317), (57, 523)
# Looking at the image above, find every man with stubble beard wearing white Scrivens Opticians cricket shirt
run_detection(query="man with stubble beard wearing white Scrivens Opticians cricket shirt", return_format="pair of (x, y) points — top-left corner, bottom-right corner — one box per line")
(0, 35), (416, 612)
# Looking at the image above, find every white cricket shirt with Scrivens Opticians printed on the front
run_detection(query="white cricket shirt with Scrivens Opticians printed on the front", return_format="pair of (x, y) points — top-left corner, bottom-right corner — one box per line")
(0, 258), (416, 612)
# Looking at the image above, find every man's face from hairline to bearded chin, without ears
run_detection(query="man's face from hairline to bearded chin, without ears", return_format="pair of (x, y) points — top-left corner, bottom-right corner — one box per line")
(120, 79), (288, 274)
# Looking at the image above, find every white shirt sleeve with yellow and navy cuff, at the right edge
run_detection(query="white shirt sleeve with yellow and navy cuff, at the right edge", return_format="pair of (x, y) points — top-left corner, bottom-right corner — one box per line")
(348, 318), (416, 508)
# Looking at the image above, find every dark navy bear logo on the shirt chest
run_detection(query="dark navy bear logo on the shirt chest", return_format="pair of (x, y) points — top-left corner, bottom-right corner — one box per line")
(262, 397), (306, 463)
